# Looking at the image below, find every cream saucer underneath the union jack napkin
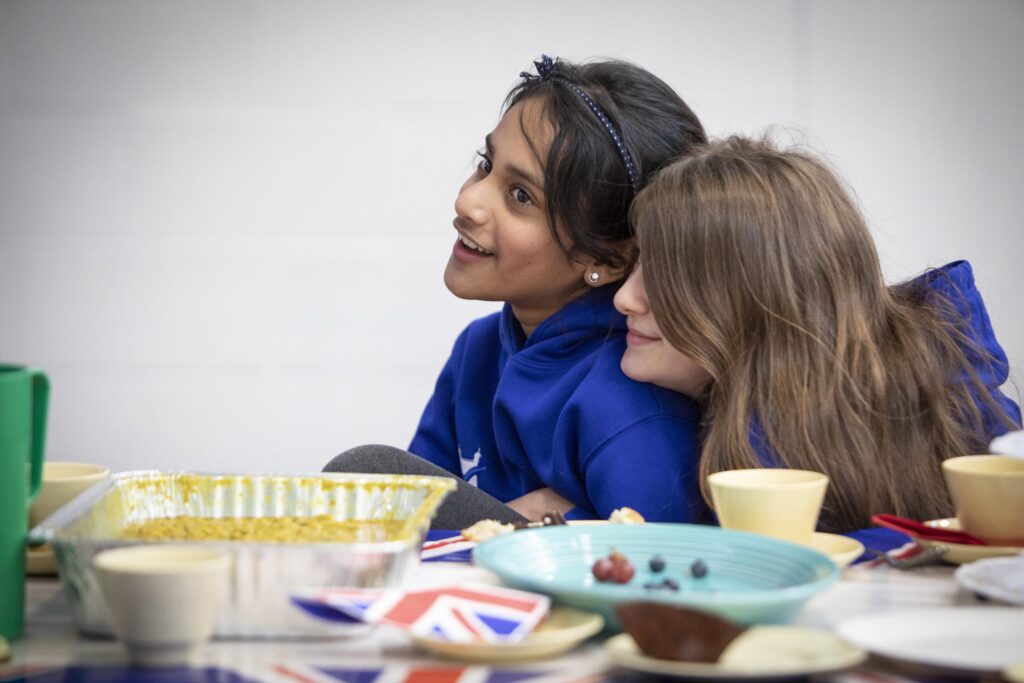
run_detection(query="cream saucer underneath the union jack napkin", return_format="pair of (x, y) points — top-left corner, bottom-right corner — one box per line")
(413, 607), (604, 661)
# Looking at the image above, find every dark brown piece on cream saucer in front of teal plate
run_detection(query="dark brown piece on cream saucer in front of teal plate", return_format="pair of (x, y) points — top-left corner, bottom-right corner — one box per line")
(615, 602), (745, 664)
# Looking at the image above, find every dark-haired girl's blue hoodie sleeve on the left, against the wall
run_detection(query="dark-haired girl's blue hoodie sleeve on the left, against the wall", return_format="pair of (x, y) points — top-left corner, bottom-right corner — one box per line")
(409, 330), (468, 476)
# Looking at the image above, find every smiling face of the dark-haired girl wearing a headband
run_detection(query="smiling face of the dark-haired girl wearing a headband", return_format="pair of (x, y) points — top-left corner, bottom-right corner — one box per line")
(444, 99), (589, 335)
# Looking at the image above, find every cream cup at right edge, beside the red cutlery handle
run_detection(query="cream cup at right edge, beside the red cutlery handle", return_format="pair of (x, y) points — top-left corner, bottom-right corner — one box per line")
(942, 455), (1024, 546)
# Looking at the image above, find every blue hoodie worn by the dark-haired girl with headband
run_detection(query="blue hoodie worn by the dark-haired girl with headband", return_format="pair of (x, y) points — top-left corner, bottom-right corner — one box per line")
(409, 285), (707, 521)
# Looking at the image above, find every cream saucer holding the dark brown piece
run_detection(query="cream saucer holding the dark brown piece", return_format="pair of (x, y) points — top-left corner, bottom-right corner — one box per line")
(604, 626), (867, 680)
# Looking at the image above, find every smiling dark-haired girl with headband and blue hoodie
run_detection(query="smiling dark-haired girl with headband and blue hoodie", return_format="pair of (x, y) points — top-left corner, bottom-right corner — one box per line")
(327, 57), (705, 528)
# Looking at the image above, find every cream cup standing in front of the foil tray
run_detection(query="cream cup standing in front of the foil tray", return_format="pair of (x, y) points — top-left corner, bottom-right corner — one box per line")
(93, 545), (232, 667)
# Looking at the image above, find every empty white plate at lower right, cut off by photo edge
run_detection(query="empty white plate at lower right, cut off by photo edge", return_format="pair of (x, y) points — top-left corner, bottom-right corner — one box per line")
(838, 606), (1024, 673)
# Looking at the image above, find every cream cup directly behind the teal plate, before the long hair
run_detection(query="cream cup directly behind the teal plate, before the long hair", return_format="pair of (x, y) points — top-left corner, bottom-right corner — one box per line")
(708, 469), (828, 544)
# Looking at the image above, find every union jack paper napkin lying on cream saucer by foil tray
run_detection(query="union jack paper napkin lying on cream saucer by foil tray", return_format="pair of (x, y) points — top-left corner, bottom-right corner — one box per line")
(292, 584), (551, 643)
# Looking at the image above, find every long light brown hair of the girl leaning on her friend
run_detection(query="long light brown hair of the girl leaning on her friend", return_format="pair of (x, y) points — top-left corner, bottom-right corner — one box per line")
(632, 137), (1014, 530)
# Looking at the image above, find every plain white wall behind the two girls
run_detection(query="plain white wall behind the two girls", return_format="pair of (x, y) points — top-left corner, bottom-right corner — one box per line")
(0, 0), (1024, 471)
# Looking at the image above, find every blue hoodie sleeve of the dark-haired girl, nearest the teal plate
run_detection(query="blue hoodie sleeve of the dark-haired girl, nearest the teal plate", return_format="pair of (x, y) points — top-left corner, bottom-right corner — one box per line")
(566, 414), (707, 522)
